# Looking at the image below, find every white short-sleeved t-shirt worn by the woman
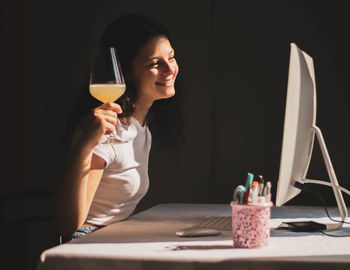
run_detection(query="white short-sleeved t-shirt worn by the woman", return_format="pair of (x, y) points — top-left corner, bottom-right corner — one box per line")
(86, 117), (151, 225)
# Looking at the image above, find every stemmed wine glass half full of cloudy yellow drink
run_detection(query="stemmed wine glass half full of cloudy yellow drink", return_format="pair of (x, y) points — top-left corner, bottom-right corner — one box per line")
(89, 47), (126, 143)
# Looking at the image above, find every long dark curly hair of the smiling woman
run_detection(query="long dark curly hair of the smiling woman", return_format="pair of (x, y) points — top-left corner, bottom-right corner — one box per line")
(64, 14), (185, 155)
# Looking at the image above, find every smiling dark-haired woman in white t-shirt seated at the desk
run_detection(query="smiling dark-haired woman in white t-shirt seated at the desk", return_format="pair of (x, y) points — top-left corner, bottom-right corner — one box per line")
(56, 15), (179, 238)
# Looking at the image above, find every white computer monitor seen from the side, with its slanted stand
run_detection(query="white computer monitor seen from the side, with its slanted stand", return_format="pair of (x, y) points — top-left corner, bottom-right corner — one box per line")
(276, 43), (347, 228)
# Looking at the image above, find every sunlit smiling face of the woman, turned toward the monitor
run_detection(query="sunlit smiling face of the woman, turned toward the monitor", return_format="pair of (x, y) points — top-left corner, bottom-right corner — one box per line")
(131, 36), (179, 103)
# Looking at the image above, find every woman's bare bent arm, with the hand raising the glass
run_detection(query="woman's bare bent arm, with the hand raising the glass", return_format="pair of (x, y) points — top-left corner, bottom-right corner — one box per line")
(55, 103), (121, 236)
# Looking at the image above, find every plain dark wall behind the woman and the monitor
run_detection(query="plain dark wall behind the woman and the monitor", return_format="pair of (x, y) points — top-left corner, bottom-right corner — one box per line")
(0, 0), (350, 268)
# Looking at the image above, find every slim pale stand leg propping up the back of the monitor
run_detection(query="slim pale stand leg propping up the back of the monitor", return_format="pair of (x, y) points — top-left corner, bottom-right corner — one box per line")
(297, 125), (349, 230)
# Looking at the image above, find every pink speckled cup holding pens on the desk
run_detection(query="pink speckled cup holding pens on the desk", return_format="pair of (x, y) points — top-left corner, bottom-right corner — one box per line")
(231, 202), (272, 248)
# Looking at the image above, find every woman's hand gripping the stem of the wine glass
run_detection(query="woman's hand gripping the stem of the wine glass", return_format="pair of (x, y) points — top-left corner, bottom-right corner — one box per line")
(80, 103), (122, 148)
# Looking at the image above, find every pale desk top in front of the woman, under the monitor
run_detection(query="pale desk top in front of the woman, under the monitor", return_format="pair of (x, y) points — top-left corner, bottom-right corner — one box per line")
(38, 204), (350, 270)
